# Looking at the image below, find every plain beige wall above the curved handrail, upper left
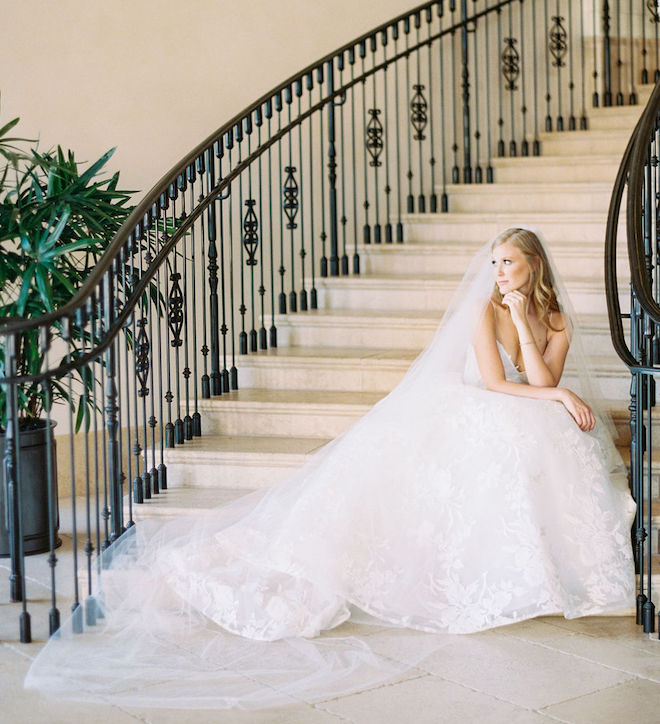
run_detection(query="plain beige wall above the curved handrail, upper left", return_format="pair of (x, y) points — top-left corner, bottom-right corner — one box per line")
(0, 0), (416, 191)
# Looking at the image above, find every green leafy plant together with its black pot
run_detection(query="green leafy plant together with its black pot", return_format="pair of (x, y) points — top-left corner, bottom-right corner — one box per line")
(0, 100), (132, 556)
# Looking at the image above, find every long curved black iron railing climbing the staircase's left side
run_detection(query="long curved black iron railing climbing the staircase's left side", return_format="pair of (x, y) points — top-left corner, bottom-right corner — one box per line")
(0, 0), (658, 641)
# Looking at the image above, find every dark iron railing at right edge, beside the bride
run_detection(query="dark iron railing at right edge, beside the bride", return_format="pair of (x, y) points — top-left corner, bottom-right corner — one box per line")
(605, 76), (660, 633)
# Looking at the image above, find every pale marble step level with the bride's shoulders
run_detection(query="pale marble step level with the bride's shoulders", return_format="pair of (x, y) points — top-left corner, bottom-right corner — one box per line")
(268, 308), (612, 354)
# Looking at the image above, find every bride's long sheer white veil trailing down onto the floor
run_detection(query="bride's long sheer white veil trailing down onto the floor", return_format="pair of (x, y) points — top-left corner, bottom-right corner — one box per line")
(26, 230), (628, 708)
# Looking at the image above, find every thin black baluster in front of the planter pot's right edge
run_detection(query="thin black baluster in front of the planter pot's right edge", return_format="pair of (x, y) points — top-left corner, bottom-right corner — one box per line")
(40, 334), (60, 636)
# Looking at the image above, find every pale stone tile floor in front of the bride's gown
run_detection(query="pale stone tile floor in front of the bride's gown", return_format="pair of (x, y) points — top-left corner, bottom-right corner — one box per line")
(0, 491), (660, 724)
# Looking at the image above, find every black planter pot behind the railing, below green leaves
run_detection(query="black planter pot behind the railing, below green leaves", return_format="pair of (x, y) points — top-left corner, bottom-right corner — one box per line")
(0, 421), (61, 558)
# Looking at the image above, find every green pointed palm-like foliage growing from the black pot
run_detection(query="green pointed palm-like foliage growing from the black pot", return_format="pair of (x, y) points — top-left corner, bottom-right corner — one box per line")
(0, 102), (133, 427)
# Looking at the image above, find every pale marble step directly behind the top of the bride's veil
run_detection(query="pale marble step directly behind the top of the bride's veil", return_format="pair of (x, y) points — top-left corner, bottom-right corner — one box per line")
(402, 211), (626, 249)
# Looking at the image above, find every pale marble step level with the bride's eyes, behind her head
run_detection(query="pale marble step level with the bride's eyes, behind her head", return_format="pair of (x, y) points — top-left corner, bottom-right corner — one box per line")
(358, 238), (628, 279)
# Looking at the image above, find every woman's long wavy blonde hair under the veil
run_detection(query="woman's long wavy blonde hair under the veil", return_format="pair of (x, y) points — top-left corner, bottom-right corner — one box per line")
(491, 228), (562, 332)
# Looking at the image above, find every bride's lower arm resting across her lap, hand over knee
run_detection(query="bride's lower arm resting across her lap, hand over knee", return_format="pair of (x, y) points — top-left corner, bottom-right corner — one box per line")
(474, 304), (596, 430)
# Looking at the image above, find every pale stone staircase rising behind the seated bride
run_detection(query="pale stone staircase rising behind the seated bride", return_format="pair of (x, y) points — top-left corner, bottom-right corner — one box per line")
(136, 80), (660, 584)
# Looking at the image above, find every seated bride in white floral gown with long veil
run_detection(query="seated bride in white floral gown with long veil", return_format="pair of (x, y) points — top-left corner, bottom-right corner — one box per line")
(26, 228), (635, 708)
